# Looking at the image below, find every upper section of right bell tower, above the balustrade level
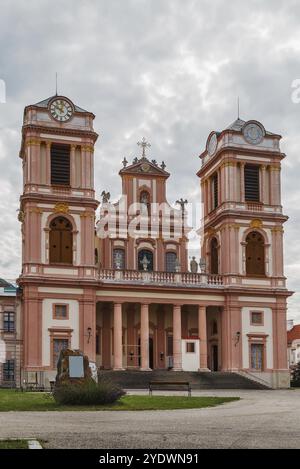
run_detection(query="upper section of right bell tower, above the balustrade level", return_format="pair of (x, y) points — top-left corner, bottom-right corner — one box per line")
(198, 119), (287, 287)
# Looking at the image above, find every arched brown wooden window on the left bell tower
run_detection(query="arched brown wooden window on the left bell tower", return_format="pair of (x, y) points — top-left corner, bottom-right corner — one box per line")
(49, 217), (73, 264)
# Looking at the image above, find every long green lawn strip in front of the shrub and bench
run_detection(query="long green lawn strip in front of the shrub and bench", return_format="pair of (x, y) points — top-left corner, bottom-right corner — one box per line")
(0, 389), (239, 412)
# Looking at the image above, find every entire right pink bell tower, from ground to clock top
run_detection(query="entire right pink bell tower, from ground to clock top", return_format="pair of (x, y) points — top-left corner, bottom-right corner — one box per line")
(198, 119), (292, 387)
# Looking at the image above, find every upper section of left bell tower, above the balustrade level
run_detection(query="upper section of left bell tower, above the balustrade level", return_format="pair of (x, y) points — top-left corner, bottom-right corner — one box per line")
(19, 96), (97, 277)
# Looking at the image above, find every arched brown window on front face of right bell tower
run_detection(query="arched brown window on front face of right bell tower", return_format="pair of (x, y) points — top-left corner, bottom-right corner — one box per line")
(246, 231), (265, 275)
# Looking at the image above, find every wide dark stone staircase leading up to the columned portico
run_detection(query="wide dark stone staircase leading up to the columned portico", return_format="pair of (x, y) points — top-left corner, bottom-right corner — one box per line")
(99, 370), (269, 389)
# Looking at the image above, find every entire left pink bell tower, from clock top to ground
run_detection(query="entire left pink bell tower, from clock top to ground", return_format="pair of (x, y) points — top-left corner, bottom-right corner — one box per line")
(19, 95), (98, 384)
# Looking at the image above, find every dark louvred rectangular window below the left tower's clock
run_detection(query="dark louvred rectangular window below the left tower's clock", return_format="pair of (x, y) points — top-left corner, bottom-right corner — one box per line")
(51, 143), (70, 186)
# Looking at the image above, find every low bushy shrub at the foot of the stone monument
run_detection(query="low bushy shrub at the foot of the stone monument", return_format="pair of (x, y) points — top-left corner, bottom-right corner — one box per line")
(53, 379), (126, 405)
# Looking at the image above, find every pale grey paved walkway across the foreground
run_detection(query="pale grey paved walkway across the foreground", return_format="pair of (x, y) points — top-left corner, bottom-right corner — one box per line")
(0, 390), (300, 448)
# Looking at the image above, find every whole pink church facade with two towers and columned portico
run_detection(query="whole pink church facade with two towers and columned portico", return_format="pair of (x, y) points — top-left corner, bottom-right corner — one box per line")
(18, 96), (290, 388)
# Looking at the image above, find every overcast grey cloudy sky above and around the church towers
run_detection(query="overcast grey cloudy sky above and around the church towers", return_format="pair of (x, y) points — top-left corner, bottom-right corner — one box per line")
(0, 0), (300, 322)
